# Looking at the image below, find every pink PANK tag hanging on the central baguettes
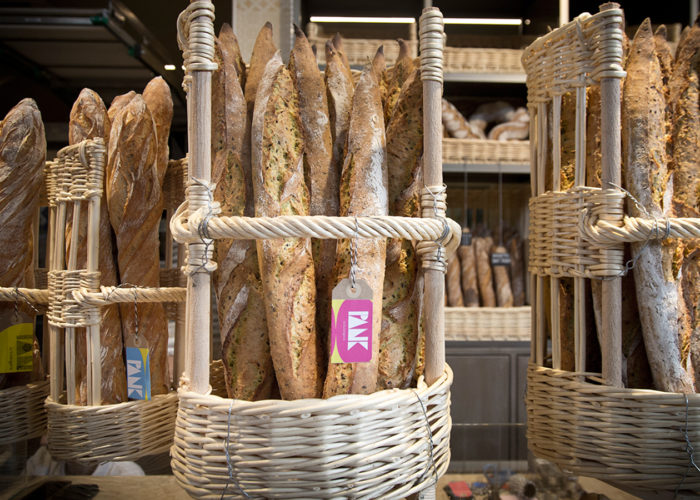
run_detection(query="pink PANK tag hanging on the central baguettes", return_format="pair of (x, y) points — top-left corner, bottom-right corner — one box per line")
(331, 278), (372, 363)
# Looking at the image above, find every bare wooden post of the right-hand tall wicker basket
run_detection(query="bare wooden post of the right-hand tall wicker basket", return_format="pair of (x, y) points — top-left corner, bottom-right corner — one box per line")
(600, 2), (622, 387)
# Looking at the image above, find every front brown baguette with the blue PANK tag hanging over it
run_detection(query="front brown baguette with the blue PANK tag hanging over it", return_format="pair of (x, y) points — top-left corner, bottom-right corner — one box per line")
(106, 95), (170, 395)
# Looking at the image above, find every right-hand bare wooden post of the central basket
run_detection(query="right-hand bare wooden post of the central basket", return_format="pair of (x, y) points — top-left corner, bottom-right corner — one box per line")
(421, 7), (445, 385)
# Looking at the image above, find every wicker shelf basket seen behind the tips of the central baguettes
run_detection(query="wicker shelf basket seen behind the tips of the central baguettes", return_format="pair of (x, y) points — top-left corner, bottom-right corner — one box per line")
(306, 23), (418, 67)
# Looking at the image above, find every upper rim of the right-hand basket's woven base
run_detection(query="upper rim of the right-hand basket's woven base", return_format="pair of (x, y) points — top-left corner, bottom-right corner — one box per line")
(528, 361), (700, 406)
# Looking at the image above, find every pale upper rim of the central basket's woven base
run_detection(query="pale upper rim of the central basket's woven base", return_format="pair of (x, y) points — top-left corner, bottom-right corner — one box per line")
(179, 363), (454, 411)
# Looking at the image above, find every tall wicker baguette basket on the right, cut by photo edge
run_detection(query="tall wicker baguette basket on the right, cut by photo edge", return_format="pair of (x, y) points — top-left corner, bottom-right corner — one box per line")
(523, 3), (700, 498)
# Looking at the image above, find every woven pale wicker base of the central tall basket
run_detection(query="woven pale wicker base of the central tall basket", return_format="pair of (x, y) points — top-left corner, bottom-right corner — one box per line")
(170, 368), (452, 499)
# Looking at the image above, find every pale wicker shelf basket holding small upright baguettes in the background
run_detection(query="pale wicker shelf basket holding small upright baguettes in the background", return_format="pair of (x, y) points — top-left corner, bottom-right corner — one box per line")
(445, 306), (531, 342)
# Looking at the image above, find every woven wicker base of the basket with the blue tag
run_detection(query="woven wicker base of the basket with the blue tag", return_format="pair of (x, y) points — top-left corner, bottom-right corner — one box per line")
(46, 392), (177, 463)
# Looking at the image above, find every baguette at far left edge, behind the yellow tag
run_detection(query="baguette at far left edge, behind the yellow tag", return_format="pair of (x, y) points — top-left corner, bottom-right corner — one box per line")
(0, 99), (46, 388)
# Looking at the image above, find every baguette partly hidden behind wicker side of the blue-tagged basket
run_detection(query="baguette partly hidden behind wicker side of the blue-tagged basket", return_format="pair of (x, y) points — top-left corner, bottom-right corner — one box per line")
(66, 89), (127, 405)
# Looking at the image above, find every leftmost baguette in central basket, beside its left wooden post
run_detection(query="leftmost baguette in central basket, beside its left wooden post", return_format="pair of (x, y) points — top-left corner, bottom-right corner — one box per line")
(211, 26), (275, 401)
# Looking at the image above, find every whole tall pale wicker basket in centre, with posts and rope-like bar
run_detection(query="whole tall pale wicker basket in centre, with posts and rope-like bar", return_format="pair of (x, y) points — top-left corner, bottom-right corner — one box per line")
(171, 1), (460, 498)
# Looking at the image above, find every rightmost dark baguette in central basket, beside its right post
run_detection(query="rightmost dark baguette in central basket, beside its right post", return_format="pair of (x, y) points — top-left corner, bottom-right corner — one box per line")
(378, 69), (423, 389)
